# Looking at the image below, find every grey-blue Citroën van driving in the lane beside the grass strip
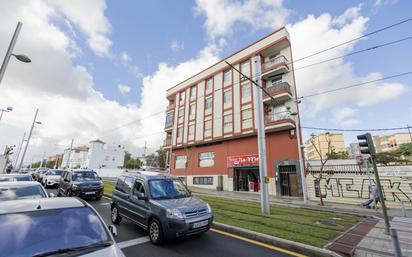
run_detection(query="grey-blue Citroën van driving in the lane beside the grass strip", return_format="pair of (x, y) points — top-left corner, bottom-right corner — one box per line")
(111, 171), (213, 244)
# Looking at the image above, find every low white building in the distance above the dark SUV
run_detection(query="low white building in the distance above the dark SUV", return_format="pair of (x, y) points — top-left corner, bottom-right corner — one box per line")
(62, 139), (125, 169)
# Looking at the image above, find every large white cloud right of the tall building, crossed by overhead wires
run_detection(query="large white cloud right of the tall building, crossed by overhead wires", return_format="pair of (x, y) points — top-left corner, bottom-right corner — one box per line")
(287, 5), (406, 113)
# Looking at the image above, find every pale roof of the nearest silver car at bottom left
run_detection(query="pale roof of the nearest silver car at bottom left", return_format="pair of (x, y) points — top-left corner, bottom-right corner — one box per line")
(0, 197), (87, 215)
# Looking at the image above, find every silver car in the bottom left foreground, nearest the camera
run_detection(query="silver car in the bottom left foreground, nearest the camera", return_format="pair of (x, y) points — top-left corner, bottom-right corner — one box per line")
(0, 198), (124, 257)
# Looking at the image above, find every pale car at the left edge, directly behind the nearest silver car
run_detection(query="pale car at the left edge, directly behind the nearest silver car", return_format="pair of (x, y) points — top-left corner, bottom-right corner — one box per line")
(0, 181), (50, 201)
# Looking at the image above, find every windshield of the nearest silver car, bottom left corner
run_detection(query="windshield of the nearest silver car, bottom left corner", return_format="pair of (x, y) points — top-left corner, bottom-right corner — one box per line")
(0, 207), (111, 257)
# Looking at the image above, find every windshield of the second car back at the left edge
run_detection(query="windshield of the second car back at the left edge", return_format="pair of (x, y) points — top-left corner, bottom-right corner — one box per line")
(0, 185), (47, 201)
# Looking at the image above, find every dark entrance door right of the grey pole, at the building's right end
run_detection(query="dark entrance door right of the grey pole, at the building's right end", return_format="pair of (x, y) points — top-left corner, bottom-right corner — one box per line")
(279, 165), (299, 196)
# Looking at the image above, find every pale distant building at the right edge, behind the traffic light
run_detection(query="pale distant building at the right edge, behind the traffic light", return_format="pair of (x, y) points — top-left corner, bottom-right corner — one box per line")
(373, 132), (412, 153)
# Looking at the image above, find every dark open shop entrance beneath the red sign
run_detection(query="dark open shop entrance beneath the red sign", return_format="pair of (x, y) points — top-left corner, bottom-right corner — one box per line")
(233, 167), (259, 192)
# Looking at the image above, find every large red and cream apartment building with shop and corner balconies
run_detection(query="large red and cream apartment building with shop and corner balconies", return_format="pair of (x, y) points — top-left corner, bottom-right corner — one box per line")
(164, 28), (302, 196)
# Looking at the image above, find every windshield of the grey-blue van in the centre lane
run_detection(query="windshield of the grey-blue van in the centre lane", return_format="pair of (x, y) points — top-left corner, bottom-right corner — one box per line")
(149, 179), (190, 199)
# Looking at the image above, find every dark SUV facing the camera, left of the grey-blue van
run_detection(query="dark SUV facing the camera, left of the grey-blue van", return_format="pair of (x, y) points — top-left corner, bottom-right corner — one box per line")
(57, 170), (104, 200)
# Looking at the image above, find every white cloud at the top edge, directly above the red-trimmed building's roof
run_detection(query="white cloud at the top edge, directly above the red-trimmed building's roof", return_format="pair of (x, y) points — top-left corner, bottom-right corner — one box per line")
(195, 0), (290, 39)
